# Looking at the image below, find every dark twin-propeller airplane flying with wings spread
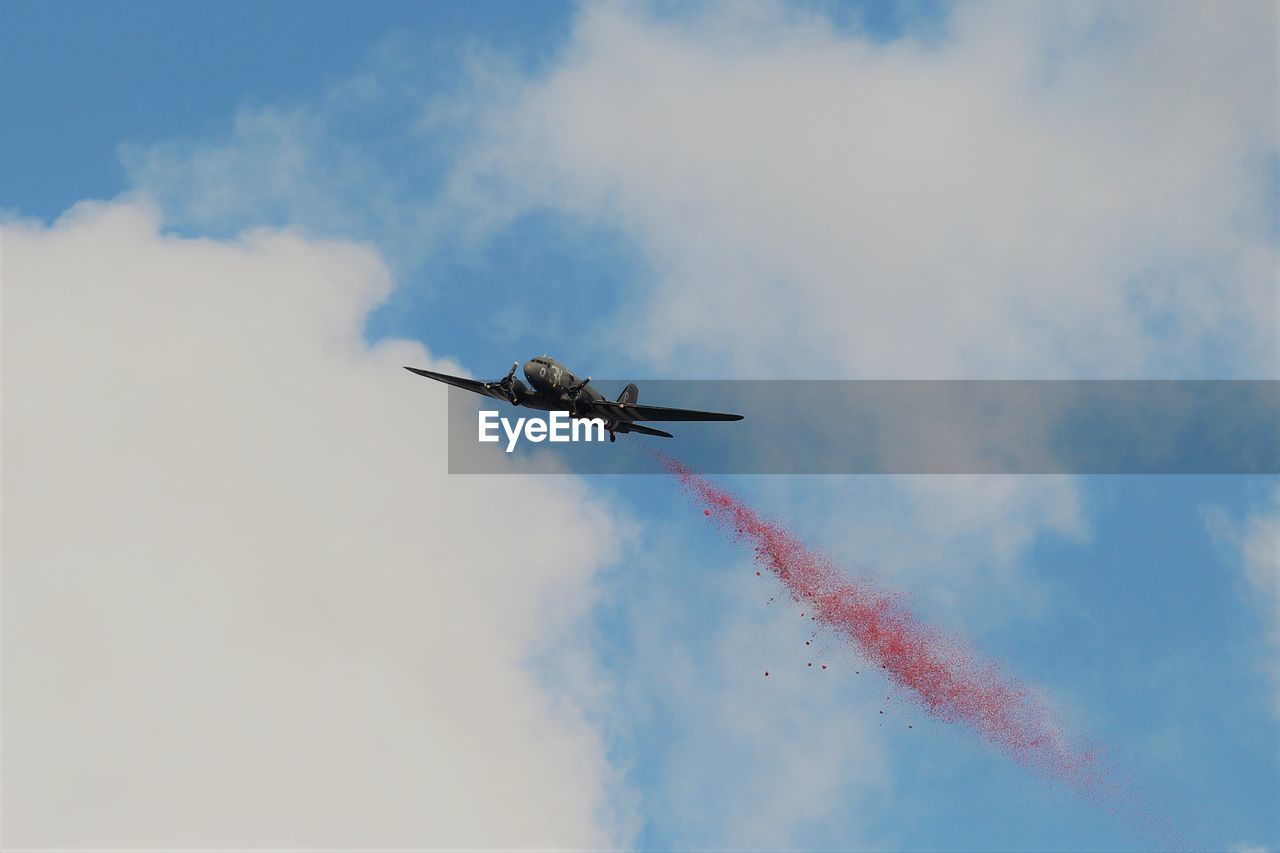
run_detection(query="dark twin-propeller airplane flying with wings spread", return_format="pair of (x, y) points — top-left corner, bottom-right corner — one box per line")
(404, 355), (742, 442)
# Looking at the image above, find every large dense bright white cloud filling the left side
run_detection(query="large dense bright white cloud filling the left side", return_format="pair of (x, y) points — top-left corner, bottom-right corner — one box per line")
(3, 204), (628, 849)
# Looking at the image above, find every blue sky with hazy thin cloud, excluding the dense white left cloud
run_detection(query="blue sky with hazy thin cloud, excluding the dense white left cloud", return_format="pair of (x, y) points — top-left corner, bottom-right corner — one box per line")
(0, 3), (1280, 849)
